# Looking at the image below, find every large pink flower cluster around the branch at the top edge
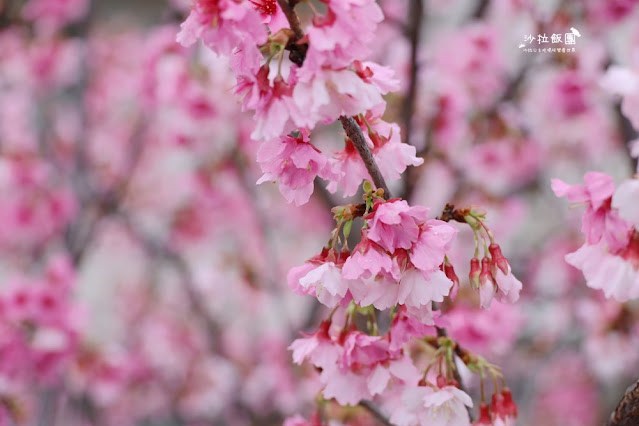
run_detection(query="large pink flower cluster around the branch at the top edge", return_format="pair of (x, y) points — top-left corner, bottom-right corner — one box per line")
(178, 0), (423, 205)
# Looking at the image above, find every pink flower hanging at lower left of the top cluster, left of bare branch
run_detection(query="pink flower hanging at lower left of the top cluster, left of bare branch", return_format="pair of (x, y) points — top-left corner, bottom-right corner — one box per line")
(257, 130), (331, 206)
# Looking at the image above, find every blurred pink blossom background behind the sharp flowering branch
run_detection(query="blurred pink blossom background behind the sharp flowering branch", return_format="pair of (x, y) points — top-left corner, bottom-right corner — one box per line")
(0, 0), (639, 426)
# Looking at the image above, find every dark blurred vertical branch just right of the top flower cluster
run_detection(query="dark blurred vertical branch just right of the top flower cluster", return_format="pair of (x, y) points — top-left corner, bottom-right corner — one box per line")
(401, 0), (424, 147)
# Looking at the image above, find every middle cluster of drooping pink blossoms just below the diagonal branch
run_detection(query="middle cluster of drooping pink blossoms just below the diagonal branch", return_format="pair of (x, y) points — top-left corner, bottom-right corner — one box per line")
(289, 199), (457, 325)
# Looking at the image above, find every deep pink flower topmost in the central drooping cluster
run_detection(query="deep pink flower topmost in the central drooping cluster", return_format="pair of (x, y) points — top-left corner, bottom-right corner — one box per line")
(367, 200), (430, 255)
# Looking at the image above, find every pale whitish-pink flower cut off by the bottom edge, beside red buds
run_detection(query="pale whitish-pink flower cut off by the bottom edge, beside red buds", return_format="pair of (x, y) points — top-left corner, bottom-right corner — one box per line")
(390, 386), (473, 426)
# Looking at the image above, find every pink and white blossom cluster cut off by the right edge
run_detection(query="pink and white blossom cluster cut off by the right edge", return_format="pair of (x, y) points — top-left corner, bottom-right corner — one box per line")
(552, 172), (639, 302)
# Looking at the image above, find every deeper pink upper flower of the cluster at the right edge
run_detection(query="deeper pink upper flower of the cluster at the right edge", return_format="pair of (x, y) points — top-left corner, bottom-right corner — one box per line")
(552, 172), (631, 251)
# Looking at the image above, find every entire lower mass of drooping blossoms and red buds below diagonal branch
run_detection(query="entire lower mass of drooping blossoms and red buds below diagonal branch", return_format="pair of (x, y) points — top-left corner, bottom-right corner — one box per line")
(288, 190), (521, 425)
